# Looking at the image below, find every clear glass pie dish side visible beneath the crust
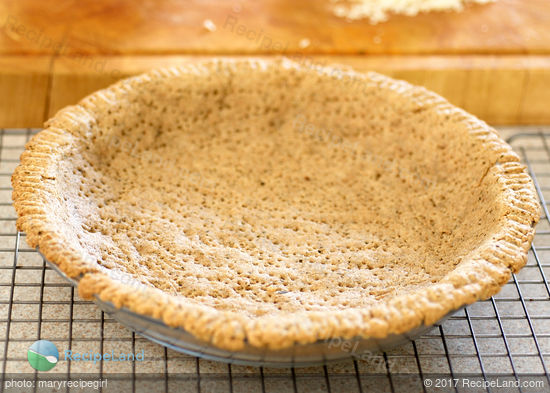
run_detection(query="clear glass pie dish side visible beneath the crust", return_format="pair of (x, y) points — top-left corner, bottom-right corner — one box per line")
(40, 248), (465, 366)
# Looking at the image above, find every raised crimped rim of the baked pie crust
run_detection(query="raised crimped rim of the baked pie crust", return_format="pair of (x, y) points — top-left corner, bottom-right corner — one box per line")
(12, 59), (539, 350)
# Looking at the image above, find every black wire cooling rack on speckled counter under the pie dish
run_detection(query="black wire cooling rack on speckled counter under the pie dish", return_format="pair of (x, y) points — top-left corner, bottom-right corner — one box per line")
(0, 127), (550, 393)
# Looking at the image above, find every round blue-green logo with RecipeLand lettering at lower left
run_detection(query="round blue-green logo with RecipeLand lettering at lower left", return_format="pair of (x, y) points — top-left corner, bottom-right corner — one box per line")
(27, 340), (145, 371)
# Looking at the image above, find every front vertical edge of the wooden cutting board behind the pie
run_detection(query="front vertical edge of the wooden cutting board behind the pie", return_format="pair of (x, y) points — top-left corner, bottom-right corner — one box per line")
(0, 55), (550, 127)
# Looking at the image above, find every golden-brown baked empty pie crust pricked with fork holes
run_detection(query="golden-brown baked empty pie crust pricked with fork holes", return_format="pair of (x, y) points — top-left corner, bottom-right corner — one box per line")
(12, 60), (539, 350)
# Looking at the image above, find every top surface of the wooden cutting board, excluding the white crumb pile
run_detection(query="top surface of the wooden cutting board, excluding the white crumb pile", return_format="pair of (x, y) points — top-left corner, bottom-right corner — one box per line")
(0, 0), (550, 55)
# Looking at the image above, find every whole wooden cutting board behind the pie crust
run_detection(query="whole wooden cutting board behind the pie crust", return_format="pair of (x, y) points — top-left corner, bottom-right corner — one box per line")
(0, 0), (550, 126)
